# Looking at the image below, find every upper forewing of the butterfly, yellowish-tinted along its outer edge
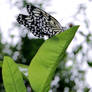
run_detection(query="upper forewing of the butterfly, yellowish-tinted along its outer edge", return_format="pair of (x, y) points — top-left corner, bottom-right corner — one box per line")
(27, 4), (64, 33)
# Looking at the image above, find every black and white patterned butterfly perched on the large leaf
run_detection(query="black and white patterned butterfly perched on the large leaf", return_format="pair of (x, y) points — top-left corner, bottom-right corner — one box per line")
(17, 4), (64, 38)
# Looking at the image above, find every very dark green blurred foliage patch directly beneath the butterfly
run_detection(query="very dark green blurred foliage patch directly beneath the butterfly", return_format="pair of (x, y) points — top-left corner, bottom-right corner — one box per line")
(20, 36), (44, 65)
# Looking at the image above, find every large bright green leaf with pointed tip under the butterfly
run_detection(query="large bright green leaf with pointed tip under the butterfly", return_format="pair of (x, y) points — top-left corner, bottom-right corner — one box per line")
(28, 26), (79, 92)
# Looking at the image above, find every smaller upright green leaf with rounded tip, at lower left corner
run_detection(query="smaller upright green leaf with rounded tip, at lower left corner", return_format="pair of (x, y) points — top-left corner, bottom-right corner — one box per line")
(2, 56), (26, 92)
